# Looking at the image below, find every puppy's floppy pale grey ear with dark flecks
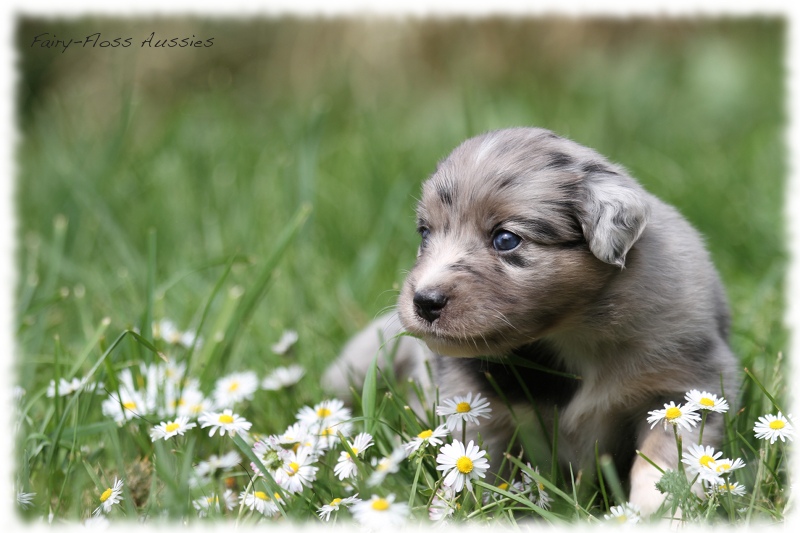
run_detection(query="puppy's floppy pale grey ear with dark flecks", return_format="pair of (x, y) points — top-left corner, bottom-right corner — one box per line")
(578, 172), (650, 268)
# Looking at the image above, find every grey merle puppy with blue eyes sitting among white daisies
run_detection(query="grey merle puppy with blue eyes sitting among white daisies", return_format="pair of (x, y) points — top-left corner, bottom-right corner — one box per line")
(324, 128), (738, 513)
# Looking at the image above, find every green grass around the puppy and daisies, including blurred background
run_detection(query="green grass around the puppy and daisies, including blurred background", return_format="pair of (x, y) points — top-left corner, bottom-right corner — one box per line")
(14, 18), (789, 524)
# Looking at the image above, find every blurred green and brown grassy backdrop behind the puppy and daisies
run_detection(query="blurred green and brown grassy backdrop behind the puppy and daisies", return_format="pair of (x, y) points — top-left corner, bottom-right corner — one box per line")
(15, 17), (787, 388)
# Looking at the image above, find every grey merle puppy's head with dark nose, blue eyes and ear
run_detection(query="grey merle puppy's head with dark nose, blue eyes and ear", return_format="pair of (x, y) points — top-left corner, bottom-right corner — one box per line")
(398, 128), (649, 356)
